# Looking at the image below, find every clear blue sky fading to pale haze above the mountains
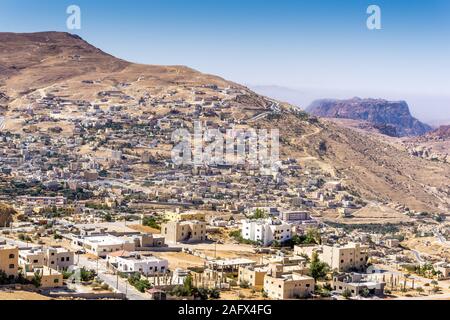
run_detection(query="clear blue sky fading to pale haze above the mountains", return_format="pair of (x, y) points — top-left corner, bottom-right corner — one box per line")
(0, 0), (450, 119)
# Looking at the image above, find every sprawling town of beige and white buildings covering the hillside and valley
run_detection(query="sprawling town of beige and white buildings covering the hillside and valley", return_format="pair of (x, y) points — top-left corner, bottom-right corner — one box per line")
(0, 79), (450, 300)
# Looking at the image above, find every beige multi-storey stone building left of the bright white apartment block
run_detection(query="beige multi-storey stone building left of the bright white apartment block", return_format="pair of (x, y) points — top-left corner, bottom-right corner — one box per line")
(161, 220), (206, 243)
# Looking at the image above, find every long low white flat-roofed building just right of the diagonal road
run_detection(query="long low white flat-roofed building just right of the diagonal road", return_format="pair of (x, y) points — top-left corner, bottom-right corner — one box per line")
(115, 252), (169, 275)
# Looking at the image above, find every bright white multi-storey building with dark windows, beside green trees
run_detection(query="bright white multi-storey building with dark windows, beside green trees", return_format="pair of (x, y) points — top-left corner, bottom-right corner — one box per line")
(241, 219), (292, 246)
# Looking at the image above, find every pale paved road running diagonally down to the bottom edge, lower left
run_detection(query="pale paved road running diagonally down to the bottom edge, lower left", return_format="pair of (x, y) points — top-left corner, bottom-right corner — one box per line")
(76, 255), (150, 300)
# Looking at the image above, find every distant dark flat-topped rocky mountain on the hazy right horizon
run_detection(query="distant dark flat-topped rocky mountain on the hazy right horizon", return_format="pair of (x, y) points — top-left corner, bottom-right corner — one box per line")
(307, 98), (432, 137)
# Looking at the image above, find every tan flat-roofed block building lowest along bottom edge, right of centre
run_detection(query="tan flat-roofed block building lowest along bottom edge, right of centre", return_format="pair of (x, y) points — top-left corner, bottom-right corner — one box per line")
(264, 273), (315, 300)
